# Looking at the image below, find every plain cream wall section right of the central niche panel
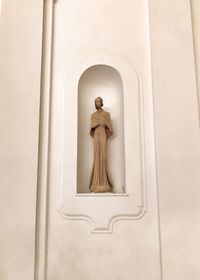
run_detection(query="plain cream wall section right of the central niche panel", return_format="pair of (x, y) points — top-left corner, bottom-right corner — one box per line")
(150, 0), (200, 280)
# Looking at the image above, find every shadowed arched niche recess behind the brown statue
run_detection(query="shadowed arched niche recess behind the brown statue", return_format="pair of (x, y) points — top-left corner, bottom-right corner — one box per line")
(77, 64), (125, 193)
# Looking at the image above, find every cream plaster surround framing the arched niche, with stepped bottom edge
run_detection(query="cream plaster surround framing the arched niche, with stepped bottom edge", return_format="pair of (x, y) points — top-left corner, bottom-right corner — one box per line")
(59, 50), (147, 233)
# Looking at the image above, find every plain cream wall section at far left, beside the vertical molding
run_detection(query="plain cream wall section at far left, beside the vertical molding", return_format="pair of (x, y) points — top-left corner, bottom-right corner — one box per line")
(0, 0), (42, 280)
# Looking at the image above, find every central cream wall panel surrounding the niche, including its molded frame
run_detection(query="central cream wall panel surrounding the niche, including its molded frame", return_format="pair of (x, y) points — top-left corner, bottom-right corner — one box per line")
(44, 0), (160, 280)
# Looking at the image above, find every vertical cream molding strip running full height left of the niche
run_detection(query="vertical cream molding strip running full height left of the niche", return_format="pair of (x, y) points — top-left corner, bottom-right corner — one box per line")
(34, 0), (56, 280)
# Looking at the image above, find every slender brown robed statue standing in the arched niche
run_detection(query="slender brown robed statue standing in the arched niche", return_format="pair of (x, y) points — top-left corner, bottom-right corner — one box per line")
(90, 97), (113, 193)
